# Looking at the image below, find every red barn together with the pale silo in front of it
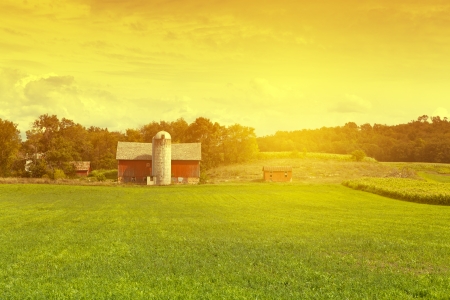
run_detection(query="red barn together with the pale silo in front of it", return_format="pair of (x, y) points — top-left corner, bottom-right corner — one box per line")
(116, 131), (201, 185)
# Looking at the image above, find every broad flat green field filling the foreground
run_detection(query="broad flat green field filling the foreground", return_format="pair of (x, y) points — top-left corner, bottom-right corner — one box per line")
(0, 183), (450, 299)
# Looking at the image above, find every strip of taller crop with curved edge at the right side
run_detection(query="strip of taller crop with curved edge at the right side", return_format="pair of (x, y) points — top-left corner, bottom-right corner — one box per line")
(342, 178), (450, 205)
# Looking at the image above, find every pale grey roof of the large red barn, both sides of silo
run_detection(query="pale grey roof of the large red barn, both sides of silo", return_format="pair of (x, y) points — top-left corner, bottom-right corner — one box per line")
(116, 142), (202, 160)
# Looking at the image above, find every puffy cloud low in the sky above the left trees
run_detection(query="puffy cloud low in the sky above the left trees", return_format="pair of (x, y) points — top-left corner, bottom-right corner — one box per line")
(0, 69), (127, 136)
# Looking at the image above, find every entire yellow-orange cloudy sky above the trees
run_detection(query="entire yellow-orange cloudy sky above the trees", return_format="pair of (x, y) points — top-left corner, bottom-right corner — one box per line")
(0, 0), (450, 136)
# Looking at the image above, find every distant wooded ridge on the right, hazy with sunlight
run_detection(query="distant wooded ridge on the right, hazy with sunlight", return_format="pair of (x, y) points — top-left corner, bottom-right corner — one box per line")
(257, 115), (450, 163)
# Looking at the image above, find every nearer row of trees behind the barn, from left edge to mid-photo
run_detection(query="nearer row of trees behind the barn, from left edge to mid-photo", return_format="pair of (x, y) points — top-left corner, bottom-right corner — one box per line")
(0, 114), (258, 177)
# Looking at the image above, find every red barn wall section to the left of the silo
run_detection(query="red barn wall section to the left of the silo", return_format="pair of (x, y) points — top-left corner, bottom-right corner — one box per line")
(117, 160), (152, 184)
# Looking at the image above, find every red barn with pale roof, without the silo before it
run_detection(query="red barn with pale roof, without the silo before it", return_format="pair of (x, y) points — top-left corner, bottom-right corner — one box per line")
(116, 142), (202, 184)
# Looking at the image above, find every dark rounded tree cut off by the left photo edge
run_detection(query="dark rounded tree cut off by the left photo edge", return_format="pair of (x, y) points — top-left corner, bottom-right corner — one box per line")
(0, 119), (21, 176)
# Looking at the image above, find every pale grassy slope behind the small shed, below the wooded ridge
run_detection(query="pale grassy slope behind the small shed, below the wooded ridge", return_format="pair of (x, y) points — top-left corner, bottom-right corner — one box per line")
(206, 152), (450, 183)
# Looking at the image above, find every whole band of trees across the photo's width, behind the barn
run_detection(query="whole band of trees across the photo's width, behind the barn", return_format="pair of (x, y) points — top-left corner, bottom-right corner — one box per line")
(0, 114), (450, 177)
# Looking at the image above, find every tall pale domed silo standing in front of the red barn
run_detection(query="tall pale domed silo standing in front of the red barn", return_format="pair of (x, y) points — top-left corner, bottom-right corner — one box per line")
(152, 131), (172, 185)
